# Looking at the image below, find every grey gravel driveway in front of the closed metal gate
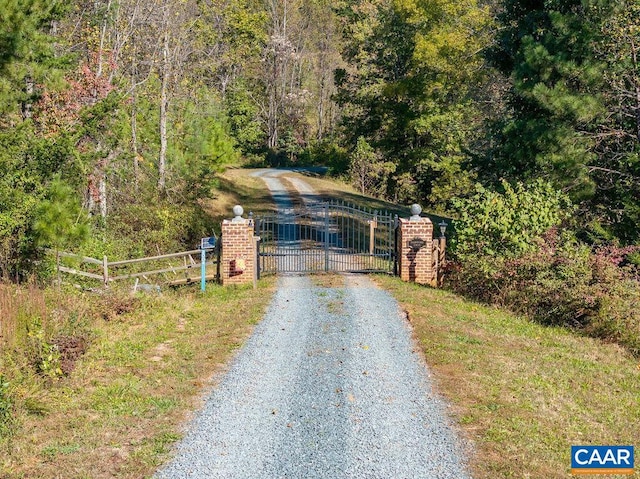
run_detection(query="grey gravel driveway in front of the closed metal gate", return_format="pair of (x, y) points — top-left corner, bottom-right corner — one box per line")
(155, 276), (470, 479)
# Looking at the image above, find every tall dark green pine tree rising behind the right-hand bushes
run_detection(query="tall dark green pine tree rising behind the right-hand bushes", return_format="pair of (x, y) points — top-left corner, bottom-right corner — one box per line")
(485, 0), (605, 199)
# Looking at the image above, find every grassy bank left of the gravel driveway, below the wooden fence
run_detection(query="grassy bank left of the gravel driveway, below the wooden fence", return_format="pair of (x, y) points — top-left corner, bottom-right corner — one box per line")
(0, 281), (273, 479)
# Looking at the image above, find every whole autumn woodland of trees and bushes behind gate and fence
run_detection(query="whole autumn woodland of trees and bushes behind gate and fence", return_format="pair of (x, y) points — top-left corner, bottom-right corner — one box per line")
(0, 0), (640, 348)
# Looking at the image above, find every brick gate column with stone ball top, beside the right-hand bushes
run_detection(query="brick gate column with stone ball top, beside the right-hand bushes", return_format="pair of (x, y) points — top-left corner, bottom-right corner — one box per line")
(397, 205), (436, 286)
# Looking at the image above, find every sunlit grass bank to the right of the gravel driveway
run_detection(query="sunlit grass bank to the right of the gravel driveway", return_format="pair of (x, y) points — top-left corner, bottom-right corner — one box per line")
(378, 277), (640, 479)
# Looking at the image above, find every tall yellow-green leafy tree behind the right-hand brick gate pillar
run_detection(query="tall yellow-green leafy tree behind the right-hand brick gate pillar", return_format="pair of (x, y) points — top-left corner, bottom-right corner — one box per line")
(336, 0), (490, 206)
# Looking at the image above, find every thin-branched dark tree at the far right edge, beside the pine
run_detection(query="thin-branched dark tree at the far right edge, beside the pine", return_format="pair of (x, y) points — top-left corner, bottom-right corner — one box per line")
(585, 1), (640, 243)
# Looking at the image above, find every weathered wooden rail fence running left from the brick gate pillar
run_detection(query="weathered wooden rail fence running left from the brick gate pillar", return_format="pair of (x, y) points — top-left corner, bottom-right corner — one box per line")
(50, 247), (220, 289)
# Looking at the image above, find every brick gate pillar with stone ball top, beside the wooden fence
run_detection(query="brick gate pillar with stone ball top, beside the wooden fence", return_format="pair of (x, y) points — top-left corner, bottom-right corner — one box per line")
(220, 206), (256, 285)
